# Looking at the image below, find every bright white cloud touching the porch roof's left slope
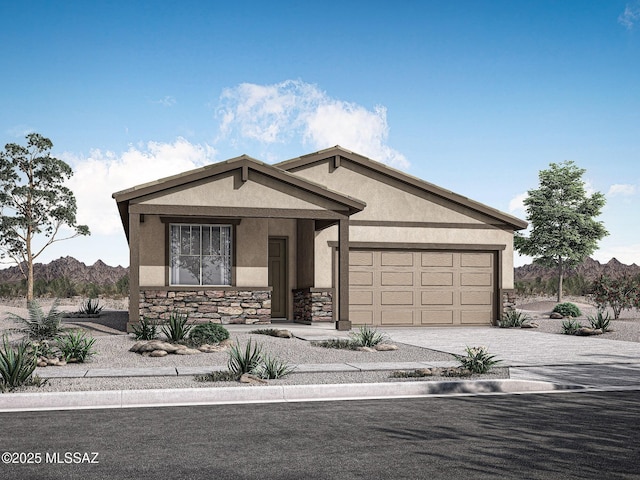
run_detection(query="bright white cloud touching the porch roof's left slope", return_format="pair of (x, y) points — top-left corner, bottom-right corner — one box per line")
(60, 138), (215, 235)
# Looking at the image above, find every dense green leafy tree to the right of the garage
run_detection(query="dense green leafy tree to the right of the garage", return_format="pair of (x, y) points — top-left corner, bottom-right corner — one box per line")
(514, 162), (608, 303)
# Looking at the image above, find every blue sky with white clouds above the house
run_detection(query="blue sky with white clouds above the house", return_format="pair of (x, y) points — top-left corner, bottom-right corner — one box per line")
(0, 0), (640, 265)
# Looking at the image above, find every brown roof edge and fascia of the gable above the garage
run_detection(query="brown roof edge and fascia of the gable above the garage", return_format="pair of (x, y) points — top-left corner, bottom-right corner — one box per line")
(274, 145), (528, 230)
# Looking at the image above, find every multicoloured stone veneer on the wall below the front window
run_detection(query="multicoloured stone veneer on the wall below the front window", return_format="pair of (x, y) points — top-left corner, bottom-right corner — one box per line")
(139, 289), (271, 324)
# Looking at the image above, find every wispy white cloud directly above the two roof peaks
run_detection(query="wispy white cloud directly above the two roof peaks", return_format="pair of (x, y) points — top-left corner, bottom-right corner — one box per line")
(217, 80), (409, 168)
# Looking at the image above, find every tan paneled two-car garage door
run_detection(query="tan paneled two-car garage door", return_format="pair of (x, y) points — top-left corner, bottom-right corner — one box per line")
(349, 250), (496, 326)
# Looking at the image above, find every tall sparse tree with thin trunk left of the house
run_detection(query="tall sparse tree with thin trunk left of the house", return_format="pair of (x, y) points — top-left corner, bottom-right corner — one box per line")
(0, 133), (89, 301)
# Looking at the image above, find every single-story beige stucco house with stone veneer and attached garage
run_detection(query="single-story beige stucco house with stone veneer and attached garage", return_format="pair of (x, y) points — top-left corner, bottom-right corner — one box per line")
(113, 146), (527, 329)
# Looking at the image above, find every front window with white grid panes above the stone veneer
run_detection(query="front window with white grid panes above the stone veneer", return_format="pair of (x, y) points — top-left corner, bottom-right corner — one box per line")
(169, 224), (231, 285)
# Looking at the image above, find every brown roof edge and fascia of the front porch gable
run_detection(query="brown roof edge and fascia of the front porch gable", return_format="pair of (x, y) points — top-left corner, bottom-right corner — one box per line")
(112, 155), (366, 238)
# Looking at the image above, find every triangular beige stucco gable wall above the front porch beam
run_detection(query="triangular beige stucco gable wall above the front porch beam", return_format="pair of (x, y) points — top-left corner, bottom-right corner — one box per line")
(137, 171), (344, 210)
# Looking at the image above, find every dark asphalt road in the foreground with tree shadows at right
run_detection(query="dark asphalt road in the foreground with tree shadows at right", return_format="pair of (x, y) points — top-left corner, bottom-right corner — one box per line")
(0, 387), (640, 480)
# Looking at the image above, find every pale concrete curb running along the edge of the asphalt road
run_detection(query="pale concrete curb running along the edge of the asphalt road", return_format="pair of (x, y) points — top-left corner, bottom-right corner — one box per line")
(0, 379), (578, 412)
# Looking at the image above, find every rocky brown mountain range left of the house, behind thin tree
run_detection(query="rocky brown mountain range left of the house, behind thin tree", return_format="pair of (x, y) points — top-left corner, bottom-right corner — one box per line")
(0, 257), (129, 285)
